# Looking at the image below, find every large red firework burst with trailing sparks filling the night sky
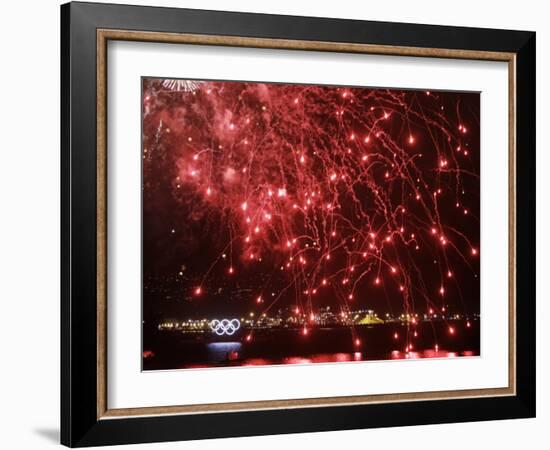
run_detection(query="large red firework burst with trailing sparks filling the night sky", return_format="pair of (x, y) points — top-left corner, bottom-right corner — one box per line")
(143, 79), (479, 345)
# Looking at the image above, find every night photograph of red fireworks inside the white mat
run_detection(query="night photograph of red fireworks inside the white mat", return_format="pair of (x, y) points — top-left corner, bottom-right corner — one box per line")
(140, 76), (484, 371)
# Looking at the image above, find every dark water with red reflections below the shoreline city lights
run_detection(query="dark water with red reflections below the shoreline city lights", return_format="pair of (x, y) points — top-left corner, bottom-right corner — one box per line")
(143, 321), (480, 370)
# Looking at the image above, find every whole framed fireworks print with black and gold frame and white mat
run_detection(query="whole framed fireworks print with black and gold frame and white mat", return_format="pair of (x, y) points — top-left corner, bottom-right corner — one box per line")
(61, 3), (535, 446)
